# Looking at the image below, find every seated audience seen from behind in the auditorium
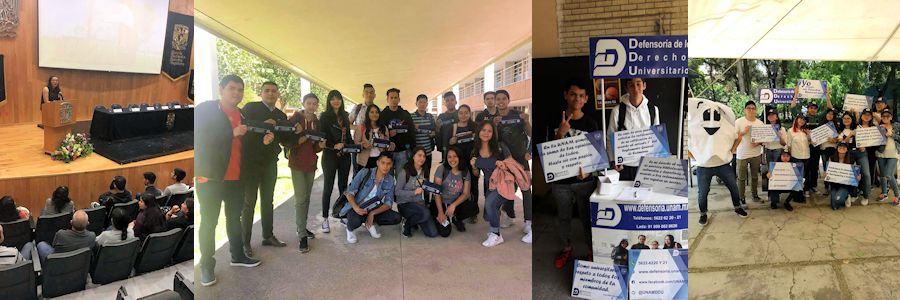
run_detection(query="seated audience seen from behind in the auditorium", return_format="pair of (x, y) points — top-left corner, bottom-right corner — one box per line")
(0, 169), (194, 265)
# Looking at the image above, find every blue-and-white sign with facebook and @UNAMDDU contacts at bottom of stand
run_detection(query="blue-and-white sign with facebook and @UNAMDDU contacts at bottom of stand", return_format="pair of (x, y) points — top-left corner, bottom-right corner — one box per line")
(628, 249), (688, 300)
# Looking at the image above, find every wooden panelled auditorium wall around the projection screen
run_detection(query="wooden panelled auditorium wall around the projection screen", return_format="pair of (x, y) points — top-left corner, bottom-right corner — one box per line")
(0, 0), (194, 125)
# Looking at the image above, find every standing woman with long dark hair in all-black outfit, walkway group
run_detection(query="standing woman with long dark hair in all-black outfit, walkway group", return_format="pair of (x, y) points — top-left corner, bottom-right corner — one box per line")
(319, 90), (352, 233)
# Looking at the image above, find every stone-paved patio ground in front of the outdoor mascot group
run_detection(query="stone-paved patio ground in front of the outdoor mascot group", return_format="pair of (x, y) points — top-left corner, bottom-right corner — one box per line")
(688, 176), (900, 299)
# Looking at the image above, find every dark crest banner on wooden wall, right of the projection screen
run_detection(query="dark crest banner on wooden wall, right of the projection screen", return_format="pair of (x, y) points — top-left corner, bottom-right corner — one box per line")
(162, 11), (194, 81)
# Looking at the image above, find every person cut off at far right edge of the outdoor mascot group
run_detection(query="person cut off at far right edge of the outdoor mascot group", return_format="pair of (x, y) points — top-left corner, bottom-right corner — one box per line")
(876, 109), (900, 206)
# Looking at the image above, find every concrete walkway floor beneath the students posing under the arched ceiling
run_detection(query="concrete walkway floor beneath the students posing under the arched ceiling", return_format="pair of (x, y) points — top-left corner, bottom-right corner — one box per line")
(197, 158), (532, 299)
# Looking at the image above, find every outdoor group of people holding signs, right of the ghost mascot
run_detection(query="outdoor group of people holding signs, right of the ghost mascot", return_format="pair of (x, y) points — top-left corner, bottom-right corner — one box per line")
(700, 86), (900, 224)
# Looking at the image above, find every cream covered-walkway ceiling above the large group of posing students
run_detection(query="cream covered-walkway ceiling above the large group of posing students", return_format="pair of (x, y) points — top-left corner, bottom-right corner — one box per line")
(195, 0), (531, 109)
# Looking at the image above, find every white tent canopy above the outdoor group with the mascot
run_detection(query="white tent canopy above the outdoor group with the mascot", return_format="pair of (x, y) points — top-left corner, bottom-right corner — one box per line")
(688, 0), (900, 61)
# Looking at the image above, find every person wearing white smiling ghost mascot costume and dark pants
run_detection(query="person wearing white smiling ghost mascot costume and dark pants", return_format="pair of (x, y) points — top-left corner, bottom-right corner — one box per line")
(688, 98), (747, 225)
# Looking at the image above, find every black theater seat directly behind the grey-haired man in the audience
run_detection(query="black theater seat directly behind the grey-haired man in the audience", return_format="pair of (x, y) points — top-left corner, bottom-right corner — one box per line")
(41, 248), (91, 298)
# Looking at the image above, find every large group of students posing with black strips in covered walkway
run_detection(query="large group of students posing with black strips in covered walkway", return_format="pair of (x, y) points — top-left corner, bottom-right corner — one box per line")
(195, 75), (532, 286)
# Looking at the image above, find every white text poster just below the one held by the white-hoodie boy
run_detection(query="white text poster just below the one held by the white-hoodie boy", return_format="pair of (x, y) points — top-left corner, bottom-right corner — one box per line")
(634, 156), (688, 197)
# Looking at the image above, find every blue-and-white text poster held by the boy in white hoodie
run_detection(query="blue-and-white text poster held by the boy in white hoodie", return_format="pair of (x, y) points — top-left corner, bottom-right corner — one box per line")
(609, 124), (672, 164)
